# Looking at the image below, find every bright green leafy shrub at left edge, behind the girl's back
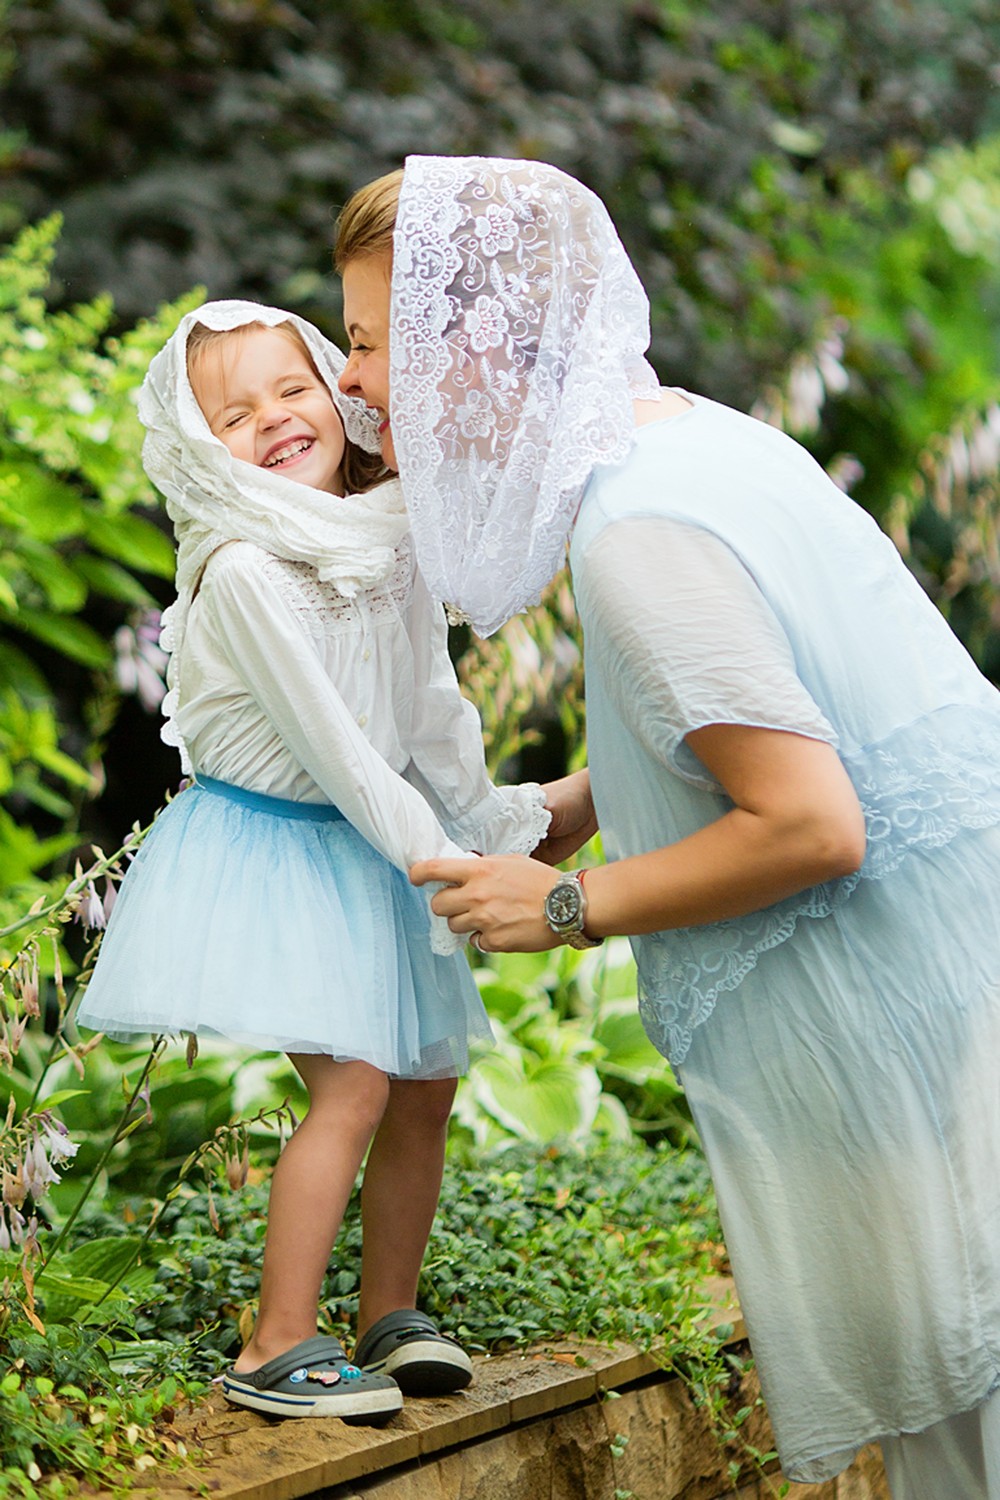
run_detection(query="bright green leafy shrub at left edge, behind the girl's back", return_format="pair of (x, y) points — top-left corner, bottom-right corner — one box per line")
(0, 216), (198, 915)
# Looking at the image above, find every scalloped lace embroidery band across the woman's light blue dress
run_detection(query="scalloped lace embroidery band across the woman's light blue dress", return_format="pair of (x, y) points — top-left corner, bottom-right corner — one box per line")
(633, 705), (1000, 1067)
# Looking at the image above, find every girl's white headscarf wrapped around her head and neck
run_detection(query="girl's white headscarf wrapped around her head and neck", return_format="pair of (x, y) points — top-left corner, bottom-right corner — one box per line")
(138, 302), (408, 773)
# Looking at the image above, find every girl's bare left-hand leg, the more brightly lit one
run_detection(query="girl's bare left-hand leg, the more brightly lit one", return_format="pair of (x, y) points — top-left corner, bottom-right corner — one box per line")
(234, 1053), (389, 1371)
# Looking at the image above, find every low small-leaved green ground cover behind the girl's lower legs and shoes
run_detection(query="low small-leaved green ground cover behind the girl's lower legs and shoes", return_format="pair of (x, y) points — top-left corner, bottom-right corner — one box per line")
(102, 1142), (718, 1376)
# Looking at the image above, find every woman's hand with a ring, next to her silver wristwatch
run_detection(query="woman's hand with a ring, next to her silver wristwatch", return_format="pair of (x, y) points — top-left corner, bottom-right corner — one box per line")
(409, 854), (559, 953)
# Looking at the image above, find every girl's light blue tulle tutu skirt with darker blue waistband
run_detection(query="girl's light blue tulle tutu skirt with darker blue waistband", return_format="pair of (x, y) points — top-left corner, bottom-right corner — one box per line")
(78, 777), (490, 1079)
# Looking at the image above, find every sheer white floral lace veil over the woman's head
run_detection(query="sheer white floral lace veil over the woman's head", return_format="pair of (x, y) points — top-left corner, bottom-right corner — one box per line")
(390, 156), (660, 635)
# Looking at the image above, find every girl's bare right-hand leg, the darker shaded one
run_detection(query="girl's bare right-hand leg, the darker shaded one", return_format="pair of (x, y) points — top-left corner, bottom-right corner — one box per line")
(358, 1079), (457, 1338)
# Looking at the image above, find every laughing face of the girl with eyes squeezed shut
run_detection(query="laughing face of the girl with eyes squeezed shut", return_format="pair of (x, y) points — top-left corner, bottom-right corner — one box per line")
(190, 326), (345, 495)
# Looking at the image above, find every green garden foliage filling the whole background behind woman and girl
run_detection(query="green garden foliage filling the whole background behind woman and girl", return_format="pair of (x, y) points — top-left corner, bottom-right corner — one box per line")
(0, 0), (1000, 1494)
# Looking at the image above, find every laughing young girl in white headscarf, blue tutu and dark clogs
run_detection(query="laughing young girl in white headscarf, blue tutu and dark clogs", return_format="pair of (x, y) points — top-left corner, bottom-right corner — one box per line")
(79, 302), (549, 1422)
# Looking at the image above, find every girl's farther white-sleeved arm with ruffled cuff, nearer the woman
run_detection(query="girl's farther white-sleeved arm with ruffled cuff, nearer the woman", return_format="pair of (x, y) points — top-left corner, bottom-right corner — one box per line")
(406, 572), (549, 854)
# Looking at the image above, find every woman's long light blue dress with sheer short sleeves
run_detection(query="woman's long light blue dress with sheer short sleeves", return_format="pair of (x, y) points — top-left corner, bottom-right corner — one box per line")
(571, 393), (1000, 1482)
